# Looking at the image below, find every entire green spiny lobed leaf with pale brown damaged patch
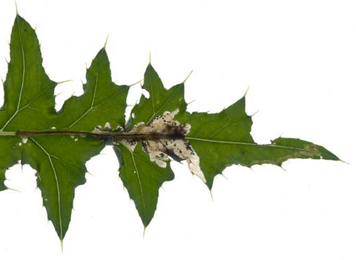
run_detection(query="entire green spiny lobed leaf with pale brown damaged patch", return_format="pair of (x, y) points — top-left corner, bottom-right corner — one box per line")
(0, 16), (339, 243)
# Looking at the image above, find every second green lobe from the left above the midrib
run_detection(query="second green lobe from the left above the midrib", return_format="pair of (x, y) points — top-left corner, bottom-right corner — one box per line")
(54, 48), (129, 131)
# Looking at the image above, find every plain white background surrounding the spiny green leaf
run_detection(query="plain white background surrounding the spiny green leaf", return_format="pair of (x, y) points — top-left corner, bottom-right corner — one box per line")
(0, 0), (356, 260)
